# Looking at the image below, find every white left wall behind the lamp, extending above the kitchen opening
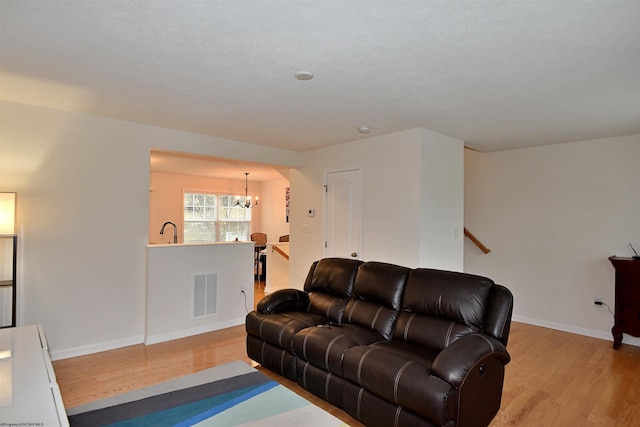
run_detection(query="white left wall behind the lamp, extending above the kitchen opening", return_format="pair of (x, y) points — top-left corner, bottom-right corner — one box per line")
(0, 102), (302, 358)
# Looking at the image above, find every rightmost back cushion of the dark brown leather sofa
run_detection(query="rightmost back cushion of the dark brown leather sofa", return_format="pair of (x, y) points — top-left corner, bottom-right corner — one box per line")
(393, 268), (494, 349)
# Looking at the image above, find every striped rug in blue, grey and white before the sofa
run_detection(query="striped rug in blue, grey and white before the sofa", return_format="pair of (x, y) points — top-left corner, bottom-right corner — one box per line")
(67, 362), (346, 427)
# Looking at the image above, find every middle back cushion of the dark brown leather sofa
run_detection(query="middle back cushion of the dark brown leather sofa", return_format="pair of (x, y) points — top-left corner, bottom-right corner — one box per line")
(343, 262), (411, 339)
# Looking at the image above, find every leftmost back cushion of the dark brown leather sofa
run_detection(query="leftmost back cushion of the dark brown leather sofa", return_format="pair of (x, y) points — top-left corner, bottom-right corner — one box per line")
(304, 258), (362, 323)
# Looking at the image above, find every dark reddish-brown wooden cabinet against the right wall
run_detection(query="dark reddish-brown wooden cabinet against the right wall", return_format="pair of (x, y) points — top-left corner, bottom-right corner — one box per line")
(609, 257), (640, 348)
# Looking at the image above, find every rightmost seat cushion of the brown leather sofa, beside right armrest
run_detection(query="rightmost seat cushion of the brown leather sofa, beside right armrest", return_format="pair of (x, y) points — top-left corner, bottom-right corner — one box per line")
(343, 343), (455, 425)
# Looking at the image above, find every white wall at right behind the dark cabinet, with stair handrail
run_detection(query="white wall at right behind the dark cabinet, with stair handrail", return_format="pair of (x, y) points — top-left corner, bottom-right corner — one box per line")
(464, 135), (640, 343)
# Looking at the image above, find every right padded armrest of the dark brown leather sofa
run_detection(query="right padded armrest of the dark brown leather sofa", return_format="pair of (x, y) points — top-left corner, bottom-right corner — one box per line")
(431, 334), (511, 387)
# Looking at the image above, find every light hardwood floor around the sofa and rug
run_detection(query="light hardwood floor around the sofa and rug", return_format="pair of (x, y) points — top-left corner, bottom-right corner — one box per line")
(54, 285), (640, 427)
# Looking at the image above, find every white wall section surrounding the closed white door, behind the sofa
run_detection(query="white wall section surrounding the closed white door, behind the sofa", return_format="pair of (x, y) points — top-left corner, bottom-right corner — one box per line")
(290, 129), (463, 288)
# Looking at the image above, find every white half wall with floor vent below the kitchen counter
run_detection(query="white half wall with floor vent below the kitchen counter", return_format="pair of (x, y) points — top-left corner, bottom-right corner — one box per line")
(145, 242), (253, 344)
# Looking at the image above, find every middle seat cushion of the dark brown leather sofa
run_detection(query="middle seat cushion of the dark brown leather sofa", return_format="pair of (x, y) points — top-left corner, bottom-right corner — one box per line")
(293, 324), (384, 376)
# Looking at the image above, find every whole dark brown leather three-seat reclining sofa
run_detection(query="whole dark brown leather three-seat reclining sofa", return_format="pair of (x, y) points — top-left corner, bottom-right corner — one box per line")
(246, 258), (513, 427)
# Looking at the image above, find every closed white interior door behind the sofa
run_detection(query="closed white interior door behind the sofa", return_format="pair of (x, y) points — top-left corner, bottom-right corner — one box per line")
(325, 169), (362, 259)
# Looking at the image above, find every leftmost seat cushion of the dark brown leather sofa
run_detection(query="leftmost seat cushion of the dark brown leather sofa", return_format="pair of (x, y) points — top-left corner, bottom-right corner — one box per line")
(245, 311), (329, 353)
